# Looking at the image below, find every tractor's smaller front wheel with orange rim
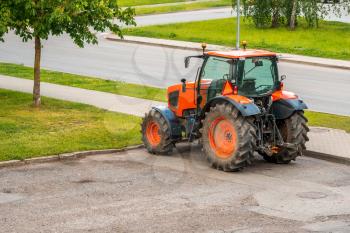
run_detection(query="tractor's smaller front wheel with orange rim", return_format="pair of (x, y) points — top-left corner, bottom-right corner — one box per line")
(141, 109), (174, 154)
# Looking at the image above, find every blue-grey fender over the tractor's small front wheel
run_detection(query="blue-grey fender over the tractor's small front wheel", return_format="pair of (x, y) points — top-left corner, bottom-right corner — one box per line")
(152, 106), (182, 139)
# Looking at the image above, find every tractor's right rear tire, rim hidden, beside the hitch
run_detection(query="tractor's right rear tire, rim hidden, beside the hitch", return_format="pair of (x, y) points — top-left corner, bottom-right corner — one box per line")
(262, 111), (310, 164)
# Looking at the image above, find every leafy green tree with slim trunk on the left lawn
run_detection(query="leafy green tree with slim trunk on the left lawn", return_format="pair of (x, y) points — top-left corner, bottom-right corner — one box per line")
(0, 0), (135, 107)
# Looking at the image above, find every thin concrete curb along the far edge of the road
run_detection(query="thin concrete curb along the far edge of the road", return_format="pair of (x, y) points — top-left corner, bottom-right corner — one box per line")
(104, 35), (350, 70)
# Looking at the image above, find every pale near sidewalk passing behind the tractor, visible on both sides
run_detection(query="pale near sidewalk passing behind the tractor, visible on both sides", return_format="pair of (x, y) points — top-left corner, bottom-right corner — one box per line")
(0, 75), (350, 164)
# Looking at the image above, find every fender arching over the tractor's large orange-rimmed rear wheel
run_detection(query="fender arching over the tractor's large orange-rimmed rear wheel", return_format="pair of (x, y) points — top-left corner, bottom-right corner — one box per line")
(201, 96), (260, 118)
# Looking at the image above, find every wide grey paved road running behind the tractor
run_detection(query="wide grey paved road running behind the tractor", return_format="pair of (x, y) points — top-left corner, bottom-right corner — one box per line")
(0, 34), (350, 115)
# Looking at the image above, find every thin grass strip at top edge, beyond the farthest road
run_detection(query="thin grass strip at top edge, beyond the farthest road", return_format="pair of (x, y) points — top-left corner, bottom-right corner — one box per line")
(135, 0), (231, 15)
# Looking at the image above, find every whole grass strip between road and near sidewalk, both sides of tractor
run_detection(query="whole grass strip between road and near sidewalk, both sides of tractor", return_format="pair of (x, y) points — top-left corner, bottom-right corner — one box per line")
(0, 63), (350, 134)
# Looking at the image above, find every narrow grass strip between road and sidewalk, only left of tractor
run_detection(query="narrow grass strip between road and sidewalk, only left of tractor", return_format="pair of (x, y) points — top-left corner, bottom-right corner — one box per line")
(0, 63), (166, 101)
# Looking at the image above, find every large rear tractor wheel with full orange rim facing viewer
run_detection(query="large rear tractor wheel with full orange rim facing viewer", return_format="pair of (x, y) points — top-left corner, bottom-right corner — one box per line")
(201, 103), (256, 171)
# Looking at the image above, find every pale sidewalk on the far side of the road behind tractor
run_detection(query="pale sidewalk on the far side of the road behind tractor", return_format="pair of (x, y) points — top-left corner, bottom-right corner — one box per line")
(104, 34), (350, 70)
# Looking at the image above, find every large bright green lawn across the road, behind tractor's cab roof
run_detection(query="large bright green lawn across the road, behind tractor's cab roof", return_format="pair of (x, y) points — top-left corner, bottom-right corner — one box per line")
(125, 18), (350, 60)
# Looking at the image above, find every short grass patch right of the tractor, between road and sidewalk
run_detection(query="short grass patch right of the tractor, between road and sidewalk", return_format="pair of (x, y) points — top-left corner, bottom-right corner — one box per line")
(305, 111), (350, 133)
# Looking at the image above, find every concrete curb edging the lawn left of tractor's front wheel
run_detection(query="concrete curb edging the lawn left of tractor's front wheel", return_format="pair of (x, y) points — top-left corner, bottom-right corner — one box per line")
(0, 145), (143, 169)
